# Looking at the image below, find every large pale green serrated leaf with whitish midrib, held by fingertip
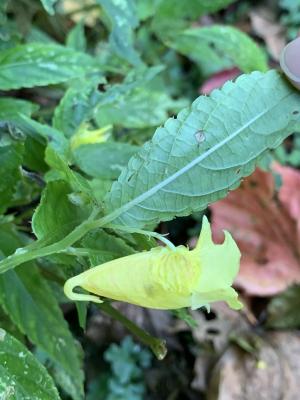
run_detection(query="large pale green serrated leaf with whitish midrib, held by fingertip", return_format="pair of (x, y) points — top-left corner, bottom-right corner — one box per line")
(105, 71), (300, 228)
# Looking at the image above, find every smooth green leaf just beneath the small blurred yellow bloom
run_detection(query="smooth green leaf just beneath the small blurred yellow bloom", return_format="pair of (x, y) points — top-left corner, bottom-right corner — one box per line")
(74, 142), (138, 179)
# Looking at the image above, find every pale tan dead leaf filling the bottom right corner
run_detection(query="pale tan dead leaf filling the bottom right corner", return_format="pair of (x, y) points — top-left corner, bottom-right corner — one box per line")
(207, 332), (300, 400)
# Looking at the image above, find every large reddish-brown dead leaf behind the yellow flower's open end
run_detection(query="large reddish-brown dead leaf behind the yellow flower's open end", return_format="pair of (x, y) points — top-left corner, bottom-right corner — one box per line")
(211, 165), (300, 296)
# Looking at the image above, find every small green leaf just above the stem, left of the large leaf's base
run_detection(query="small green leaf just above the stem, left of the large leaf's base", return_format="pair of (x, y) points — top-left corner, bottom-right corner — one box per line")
(32, 181), (90, 241)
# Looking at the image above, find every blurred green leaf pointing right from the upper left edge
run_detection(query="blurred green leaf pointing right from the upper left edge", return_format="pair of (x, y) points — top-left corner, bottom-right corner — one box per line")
(0, 43), (97, 90)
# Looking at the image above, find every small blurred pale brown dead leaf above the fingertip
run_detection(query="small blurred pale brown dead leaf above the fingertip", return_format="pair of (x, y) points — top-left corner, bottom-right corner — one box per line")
(250, 7), (286, 61)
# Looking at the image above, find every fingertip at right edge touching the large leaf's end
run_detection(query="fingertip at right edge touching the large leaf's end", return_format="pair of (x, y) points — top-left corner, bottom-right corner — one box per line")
(280, 37), (300, 88)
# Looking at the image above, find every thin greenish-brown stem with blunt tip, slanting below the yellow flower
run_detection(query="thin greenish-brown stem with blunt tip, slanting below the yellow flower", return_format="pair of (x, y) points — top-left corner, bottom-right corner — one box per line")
(97, 302), (167, 360)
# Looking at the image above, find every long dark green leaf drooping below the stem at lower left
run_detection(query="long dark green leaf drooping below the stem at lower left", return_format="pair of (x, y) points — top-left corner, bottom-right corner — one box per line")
(0, 224), (83, 400)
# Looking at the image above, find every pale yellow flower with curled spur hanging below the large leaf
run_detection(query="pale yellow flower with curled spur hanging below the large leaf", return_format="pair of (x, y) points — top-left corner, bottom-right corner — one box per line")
(64, 217), (242, 310)
